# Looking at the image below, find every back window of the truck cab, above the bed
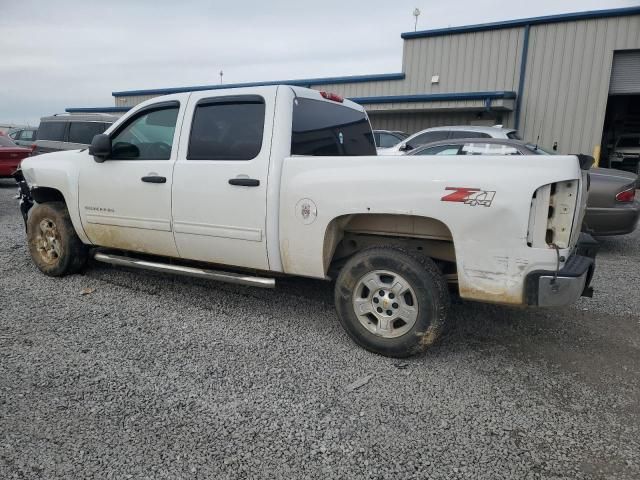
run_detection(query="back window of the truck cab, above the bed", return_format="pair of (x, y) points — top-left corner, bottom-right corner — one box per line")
(291, 97), (376, 156)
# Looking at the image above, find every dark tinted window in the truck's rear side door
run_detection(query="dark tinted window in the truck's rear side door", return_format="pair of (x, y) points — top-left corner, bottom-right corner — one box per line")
(187, 95), (265, 160)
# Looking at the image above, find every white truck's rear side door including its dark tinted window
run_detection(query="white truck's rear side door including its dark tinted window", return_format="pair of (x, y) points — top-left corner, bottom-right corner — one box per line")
(172, 88), (276, 270)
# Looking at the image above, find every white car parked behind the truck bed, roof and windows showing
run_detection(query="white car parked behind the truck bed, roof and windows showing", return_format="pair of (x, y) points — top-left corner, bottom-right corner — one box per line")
(378, 125), (520, 155)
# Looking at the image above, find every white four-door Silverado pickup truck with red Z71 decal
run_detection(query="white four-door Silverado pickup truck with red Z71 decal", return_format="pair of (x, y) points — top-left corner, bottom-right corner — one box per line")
(17, 85), (595, 356)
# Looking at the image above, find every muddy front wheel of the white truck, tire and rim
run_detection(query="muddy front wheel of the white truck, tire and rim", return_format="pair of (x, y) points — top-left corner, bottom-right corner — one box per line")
(27, 202), (89, 277)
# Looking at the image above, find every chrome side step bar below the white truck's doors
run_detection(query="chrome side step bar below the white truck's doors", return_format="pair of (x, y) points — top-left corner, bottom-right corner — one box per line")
(93, 252), (276, 288)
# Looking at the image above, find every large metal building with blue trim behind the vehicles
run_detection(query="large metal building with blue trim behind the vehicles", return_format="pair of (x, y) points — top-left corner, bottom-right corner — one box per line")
(67, 7), (640, 163)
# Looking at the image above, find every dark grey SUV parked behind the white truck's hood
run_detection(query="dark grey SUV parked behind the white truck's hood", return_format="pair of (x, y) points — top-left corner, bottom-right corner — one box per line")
(34, 113), (118, 155)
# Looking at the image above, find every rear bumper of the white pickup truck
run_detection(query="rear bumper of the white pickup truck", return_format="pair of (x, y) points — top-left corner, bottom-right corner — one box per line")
(525, 233), (598, 307)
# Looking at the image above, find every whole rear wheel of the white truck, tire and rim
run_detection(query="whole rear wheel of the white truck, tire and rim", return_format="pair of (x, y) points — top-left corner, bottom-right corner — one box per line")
(335, 247), (450, 358)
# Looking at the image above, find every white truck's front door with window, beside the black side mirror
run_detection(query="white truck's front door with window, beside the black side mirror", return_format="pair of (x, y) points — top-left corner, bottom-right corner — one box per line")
(78, 101), (184, 257)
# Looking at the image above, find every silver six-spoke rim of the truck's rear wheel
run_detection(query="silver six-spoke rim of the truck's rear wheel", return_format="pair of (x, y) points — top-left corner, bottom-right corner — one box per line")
(353, 270), (418, 338)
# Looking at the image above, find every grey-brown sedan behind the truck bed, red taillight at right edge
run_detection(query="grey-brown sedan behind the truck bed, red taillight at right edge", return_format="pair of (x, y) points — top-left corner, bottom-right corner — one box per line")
(408, 139), (640, 236)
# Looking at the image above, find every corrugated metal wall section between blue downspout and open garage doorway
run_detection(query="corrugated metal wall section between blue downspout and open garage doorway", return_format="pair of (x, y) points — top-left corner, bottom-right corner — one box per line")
(520, 15), (640, 154)
